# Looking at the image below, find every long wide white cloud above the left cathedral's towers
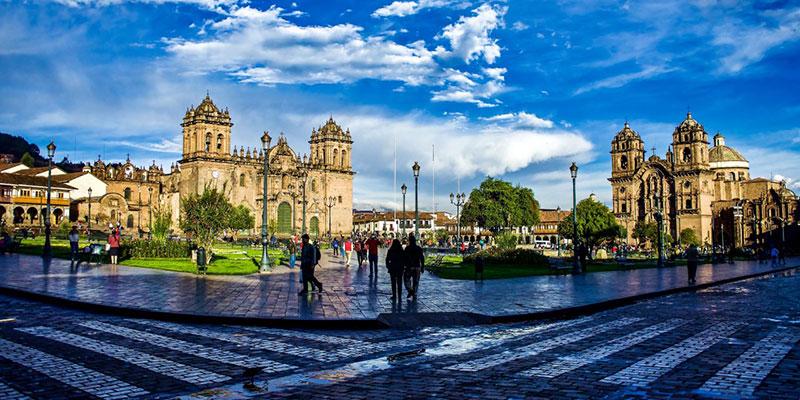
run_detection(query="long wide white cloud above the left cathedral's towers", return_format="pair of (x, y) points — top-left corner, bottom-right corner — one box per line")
(165, 7), (438, 86)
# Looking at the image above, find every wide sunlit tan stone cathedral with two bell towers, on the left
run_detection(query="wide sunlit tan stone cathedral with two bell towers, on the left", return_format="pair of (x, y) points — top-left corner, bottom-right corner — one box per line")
(74, 95), (355, 237)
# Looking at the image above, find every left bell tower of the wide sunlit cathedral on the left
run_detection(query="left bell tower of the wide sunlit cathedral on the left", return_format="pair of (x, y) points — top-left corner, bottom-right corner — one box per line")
(181, 93), (233, 160)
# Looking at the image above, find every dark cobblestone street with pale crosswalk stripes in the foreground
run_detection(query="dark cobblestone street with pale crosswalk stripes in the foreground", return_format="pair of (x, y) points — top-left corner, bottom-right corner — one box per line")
(0, 270), (800, 399)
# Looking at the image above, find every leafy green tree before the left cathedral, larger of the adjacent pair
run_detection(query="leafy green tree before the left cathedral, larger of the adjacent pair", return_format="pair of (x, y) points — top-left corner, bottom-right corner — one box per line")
(180, 186), (233, 255)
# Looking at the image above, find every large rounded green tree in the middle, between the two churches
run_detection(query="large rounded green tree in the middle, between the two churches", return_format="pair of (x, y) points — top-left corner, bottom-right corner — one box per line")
(461, 176), (539, 233)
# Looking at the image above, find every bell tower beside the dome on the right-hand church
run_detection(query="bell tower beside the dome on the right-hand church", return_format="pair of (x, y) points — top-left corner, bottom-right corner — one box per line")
(672, 112), (708, 171)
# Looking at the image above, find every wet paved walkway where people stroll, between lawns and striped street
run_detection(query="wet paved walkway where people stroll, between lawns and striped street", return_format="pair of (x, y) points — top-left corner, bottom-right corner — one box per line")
(0, 254), (800, 328)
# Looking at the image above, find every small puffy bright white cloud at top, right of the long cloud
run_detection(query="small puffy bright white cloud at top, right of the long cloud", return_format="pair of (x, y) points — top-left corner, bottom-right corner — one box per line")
(435, 4), (508, 64)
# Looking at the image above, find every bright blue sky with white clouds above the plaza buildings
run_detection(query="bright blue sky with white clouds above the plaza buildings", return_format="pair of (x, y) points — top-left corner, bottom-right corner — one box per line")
(0, 0), (800, 210)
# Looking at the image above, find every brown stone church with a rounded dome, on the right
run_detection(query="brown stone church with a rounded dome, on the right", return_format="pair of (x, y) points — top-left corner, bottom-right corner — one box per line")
(609, 113), (798, 247)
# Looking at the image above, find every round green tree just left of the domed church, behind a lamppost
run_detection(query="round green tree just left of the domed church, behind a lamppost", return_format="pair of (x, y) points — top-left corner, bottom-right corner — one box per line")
(558, 199), (620, 247)
